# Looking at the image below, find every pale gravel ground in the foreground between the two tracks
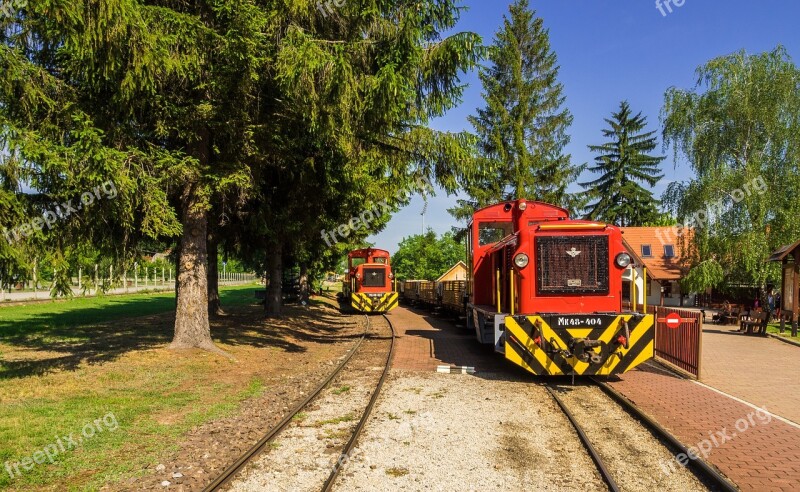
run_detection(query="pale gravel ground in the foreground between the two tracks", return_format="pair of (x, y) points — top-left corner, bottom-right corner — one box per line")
(335, 372), (606, 492)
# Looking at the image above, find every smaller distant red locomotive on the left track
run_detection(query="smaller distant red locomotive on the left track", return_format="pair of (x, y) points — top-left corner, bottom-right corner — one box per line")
(342, 248), (398, 313)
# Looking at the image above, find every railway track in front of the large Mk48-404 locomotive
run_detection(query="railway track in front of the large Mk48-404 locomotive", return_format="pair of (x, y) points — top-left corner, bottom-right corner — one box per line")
(544, 378), (738, 492)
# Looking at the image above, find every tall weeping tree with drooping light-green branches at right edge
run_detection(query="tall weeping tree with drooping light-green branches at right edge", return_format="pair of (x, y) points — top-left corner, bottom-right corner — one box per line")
(662, 47), (800, 291)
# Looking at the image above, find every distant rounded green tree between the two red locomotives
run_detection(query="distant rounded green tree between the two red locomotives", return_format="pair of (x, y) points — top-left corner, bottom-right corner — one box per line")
(392, 229), (466, 280)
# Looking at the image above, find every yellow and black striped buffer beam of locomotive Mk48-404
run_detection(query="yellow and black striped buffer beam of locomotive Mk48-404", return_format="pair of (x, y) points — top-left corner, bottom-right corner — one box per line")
(505, 313), (655, 376)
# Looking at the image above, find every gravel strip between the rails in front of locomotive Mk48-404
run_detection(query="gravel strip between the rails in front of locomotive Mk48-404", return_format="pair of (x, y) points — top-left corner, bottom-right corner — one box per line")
(556, 385), (708, 492)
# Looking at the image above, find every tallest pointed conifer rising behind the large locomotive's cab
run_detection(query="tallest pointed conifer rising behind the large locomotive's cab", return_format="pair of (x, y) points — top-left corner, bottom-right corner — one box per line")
(451, 0), (583, 218)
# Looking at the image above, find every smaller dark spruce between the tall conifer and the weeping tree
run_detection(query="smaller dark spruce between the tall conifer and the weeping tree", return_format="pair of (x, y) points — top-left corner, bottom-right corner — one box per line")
(581, 101), (665, 226)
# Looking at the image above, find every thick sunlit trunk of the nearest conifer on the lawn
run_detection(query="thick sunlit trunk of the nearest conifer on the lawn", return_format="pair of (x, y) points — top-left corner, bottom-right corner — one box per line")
(170, 183), (219, 351)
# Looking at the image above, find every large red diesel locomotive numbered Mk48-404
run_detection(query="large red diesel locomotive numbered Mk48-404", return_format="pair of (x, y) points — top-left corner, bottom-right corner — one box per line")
(466, 200), (654, 376)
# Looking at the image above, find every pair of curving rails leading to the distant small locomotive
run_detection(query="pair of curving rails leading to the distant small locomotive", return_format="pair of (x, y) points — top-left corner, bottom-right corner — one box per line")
(203, 315), (395, 492)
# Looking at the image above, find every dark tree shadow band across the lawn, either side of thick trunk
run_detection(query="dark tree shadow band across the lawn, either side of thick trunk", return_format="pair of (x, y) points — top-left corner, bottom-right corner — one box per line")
(0, 299), (360, 381)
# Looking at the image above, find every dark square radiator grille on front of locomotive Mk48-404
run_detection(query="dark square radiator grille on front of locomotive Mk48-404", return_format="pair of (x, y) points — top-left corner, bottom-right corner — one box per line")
(536, 236), (609, 295)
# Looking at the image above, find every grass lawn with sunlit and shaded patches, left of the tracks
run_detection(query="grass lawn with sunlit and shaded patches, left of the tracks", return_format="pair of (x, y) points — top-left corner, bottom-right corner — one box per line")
(0, 285), (272, 490)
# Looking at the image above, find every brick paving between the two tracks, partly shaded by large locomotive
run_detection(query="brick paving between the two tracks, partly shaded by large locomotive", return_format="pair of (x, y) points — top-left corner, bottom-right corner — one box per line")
(389, 307), (494, 371)
